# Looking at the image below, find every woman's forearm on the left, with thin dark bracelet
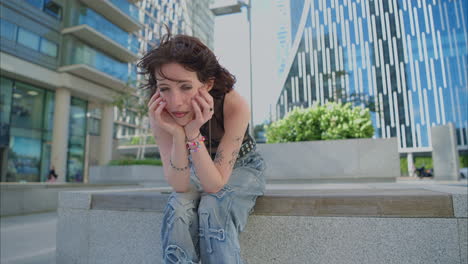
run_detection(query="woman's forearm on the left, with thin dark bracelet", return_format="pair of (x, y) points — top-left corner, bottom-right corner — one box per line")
(164, 133), (190, 192)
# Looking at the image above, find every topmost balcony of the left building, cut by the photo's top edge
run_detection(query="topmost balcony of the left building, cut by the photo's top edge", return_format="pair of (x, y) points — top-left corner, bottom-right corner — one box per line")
(80, 0), (143, 32)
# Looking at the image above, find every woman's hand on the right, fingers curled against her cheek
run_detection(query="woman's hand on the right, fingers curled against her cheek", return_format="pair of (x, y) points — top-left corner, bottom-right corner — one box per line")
(184, 88), (214, 138)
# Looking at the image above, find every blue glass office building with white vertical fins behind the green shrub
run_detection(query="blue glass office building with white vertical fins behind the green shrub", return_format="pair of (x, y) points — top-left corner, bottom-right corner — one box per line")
(276, 0), (468, 152)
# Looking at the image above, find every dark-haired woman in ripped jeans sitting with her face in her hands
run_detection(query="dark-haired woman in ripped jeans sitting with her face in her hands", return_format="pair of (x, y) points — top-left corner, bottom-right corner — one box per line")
(138, 34), (265, 264)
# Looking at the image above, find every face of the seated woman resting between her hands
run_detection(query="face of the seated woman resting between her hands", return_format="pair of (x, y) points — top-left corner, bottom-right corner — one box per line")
(155, 63), (208, 126)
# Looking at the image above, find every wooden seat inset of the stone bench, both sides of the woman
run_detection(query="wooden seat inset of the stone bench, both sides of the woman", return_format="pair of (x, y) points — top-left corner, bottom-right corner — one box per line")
(87, 189), (454, 218)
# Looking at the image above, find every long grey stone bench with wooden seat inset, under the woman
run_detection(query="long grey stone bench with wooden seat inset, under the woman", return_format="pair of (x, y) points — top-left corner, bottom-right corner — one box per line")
(57, 184), (468, 264)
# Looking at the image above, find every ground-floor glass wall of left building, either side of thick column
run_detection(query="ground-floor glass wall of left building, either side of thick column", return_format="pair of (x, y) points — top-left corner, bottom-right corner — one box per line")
(0, 77), (87, 182)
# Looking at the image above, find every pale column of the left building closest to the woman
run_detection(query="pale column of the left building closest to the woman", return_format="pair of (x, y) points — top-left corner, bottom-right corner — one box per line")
(99, 105), (114, 166)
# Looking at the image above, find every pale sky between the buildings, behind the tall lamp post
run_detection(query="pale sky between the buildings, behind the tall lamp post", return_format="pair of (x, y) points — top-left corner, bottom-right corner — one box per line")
(214, 0), (288, 125)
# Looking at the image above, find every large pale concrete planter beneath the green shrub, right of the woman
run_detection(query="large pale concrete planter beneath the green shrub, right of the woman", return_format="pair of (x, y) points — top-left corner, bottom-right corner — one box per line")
(258, 138), (400, 183)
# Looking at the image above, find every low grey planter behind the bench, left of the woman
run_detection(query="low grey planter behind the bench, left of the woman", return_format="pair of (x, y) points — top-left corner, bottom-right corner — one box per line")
(89, 165), (167, 185)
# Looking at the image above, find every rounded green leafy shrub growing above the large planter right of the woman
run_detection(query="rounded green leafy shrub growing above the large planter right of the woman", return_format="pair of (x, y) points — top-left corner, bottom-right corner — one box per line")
(266, 103), (374, 143)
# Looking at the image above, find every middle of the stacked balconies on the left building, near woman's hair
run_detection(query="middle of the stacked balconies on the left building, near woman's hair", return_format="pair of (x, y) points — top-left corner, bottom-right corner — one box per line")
(62, 25), (139, 62)
